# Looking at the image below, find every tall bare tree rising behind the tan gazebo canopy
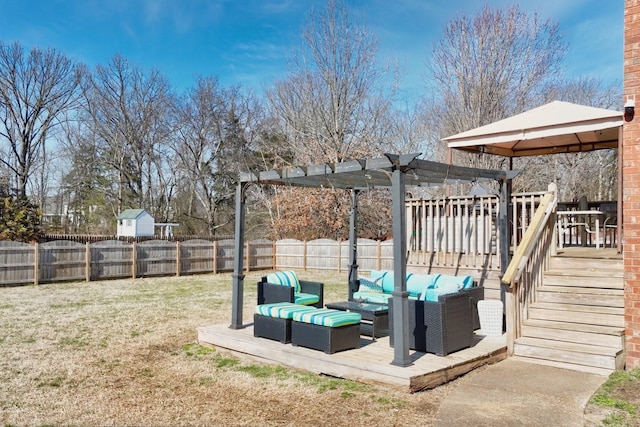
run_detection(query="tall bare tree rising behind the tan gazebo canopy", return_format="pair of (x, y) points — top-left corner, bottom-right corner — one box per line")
(427, 5), (566, 171)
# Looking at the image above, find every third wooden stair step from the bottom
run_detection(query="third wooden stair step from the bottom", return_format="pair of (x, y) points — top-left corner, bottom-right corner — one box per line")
(529, 302), (624, 328)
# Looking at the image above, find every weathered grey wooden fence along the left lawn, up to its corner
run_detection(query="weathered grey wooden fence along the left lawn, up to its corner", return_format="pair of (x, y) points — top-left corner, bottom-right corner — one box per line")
(0, 240), (274, 285)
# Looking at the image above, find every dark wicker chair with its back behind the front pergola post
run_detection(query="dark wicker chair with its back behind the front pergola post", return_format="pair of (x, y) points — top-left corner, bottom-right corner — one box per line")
(389, 292), (473, 356)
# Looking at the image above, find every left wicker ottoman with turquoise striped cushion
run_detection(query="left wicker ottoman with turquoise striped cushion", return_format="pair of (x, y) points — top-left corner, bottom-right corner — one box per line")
(253, 302), (316, 344)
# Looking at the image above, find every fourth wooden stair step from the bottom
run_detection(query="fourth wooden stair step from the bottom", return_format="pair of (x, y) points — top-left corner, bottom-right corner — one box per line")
(538, 285), (624, 308)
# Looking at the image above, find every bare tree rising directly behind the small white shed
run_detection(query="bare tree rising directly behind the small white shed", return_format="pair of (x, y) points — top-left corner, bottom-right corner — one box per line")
(84, 55), (174, 214)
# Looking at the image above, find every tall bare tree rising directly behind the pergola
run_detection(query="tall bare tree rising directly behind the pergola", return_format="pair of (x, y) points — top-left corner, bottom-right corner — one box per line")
(263, 0), (395, 238)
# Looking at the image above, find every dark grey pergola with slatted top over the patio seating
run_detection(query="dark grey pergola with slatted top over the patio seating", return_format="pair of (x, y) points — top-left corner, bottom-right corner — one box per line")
(230, 153), (515, 366)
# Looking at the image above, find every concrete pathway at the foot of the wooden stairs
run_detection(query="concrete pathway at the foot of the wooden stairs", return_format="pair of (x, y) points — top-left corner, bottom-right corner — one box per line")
(434, 358), (607, 427)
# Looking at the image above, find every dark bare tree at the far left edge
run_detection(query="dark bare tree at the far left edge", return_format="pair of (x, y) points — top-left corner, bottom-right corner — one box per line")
(0, 42), (81, 196)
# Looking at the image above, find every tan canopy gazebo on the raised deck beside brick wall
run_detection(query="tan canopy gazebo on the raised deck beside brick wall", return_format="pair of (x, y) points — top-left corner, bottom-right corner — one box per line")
(442, 101), (623, 252)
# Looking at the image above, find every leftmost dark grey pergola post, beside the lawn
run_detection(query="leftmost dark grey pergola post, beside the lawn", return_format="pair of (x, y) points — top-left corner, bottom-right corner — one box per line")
(229, 182), (245, 329)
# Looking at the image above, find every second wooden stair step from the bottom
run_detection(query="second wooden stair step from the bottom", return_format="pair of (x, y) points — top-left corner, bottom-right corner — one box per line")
(522, 319), (624, 350)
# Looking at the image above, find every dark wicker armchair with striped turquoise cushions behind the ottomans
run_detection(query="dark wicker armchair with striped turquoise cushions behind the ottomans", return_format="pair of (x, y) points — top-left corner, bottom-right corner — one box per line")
(257, 271), (324, 308)
